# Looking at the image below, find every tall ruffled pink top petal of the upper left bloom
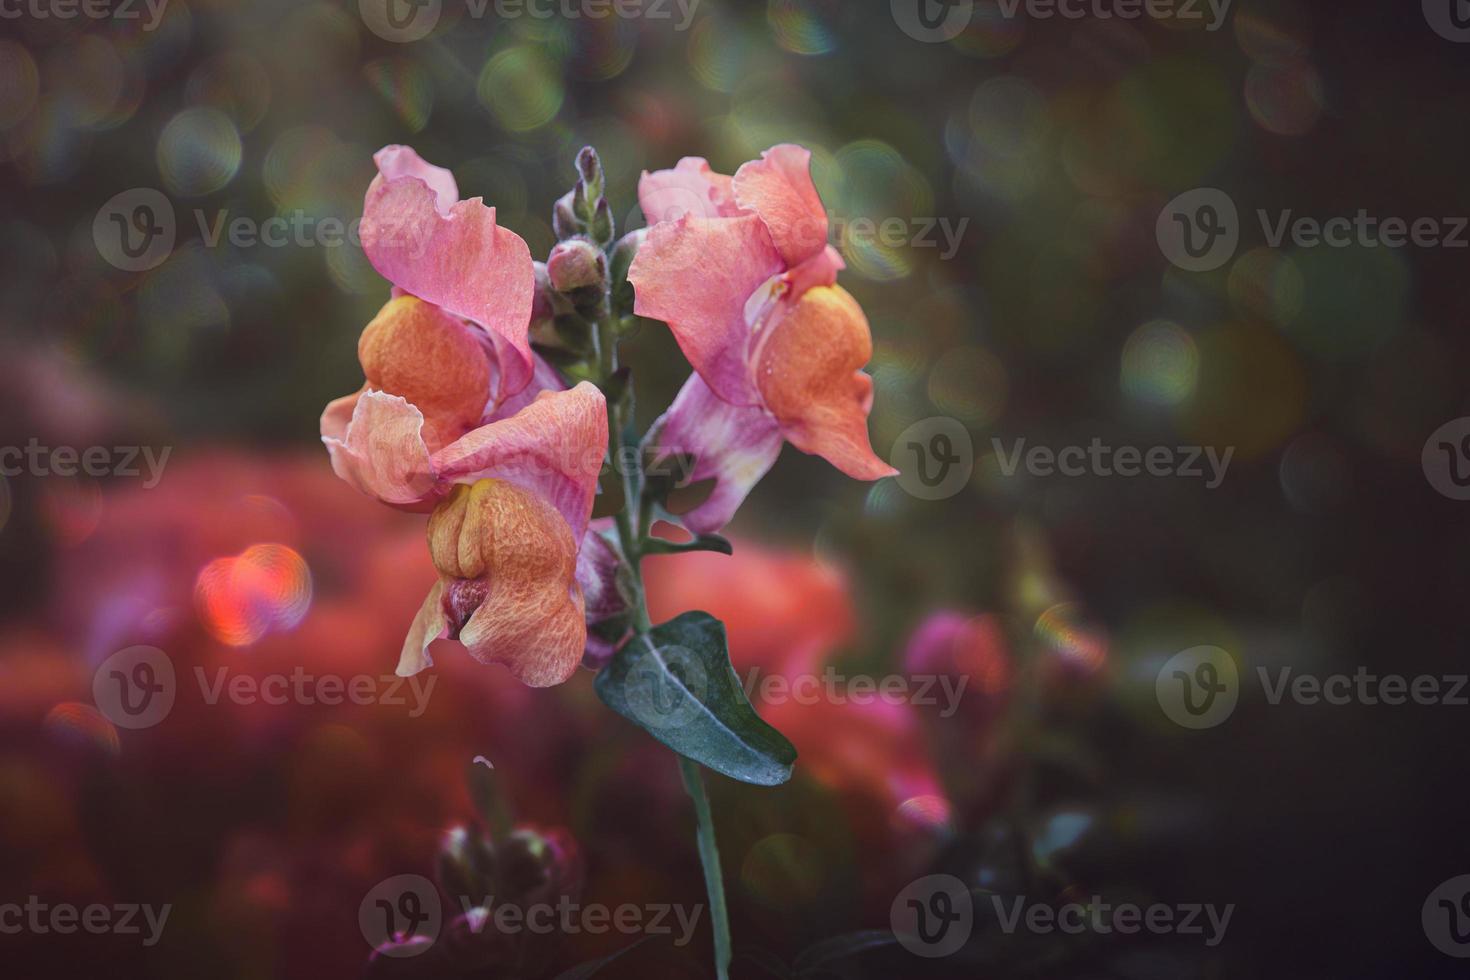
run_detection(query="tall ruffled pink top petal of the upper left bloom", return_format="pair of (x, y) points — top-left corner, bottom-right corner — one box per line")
(362, 147), (535, 398)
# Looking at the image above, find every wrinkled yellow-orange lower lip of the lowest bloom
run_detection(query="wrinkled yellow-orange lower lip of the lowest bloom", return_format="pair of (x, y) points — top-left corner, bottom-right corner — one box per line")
(456, 480), (587, 688)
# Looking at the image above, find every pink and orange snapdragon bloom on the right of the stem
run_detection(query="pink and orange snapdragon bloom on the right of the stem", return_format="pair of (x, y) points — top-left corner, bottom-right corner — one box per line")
(628, 144), (897, 532)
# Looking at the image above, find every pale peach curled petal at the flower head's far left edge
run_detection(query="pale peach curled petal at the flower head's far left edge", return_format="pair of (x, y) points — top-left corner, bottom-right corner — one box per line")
(322, 391), (437, 508)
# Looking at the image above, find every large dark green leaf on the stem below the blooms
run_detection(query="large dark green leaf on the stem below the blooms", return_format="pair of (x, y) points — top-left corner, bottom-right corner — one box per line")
(594, 611), (797, 786)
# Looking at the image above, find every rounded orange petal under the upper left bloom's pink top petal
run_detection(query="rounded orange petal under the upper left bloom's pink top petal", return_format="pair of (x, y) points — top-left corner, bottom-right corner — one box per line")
(357, 295), (491, 451)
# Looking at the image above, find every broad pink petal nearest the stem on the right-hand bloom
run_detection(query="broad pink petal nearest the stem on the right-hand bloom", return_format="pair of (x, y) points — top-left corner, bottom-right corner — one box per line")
(628, 215), (782, 406)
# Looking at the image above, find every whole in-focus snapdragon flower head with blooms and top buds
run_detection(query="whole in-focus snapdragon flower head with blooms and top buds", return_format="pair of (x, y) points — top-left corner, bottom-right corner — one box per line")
(322, 145), (894, 686)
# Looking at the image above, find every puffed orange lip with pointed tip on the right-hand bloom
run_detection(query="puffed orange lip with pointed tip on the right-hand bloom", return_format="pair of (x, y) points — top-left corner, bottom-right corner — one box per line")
(756, 287), (897, 480)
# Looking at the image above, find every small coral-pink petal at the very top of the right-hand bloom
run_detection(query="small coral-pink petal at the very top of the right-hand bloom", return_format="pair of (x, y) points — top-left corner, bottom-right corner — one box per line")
(734, 143), (828, 267)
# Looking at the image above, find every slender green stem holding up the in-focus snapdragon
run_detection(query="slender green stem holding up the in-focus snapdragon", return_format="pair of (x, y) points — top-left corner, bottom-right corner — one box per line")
(595, 310), (731, 980)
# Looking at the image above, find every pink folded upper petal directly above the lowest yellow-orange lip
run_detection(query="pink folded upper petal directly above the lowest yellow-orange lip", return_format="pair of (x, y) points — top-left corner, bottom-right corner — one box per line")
(434, 381), (607, 541)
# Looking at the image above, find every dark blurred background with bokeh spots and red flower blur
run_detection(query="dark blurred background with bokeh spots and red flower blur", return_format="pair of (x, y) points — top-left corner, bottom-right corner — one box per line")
(0, 0), (1470, 979)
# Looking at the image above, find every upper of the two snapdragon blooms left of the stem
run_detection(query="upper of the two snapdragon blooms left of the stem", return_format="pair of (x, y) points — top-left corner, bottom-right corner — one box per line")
(322, 147), (562, 510)
